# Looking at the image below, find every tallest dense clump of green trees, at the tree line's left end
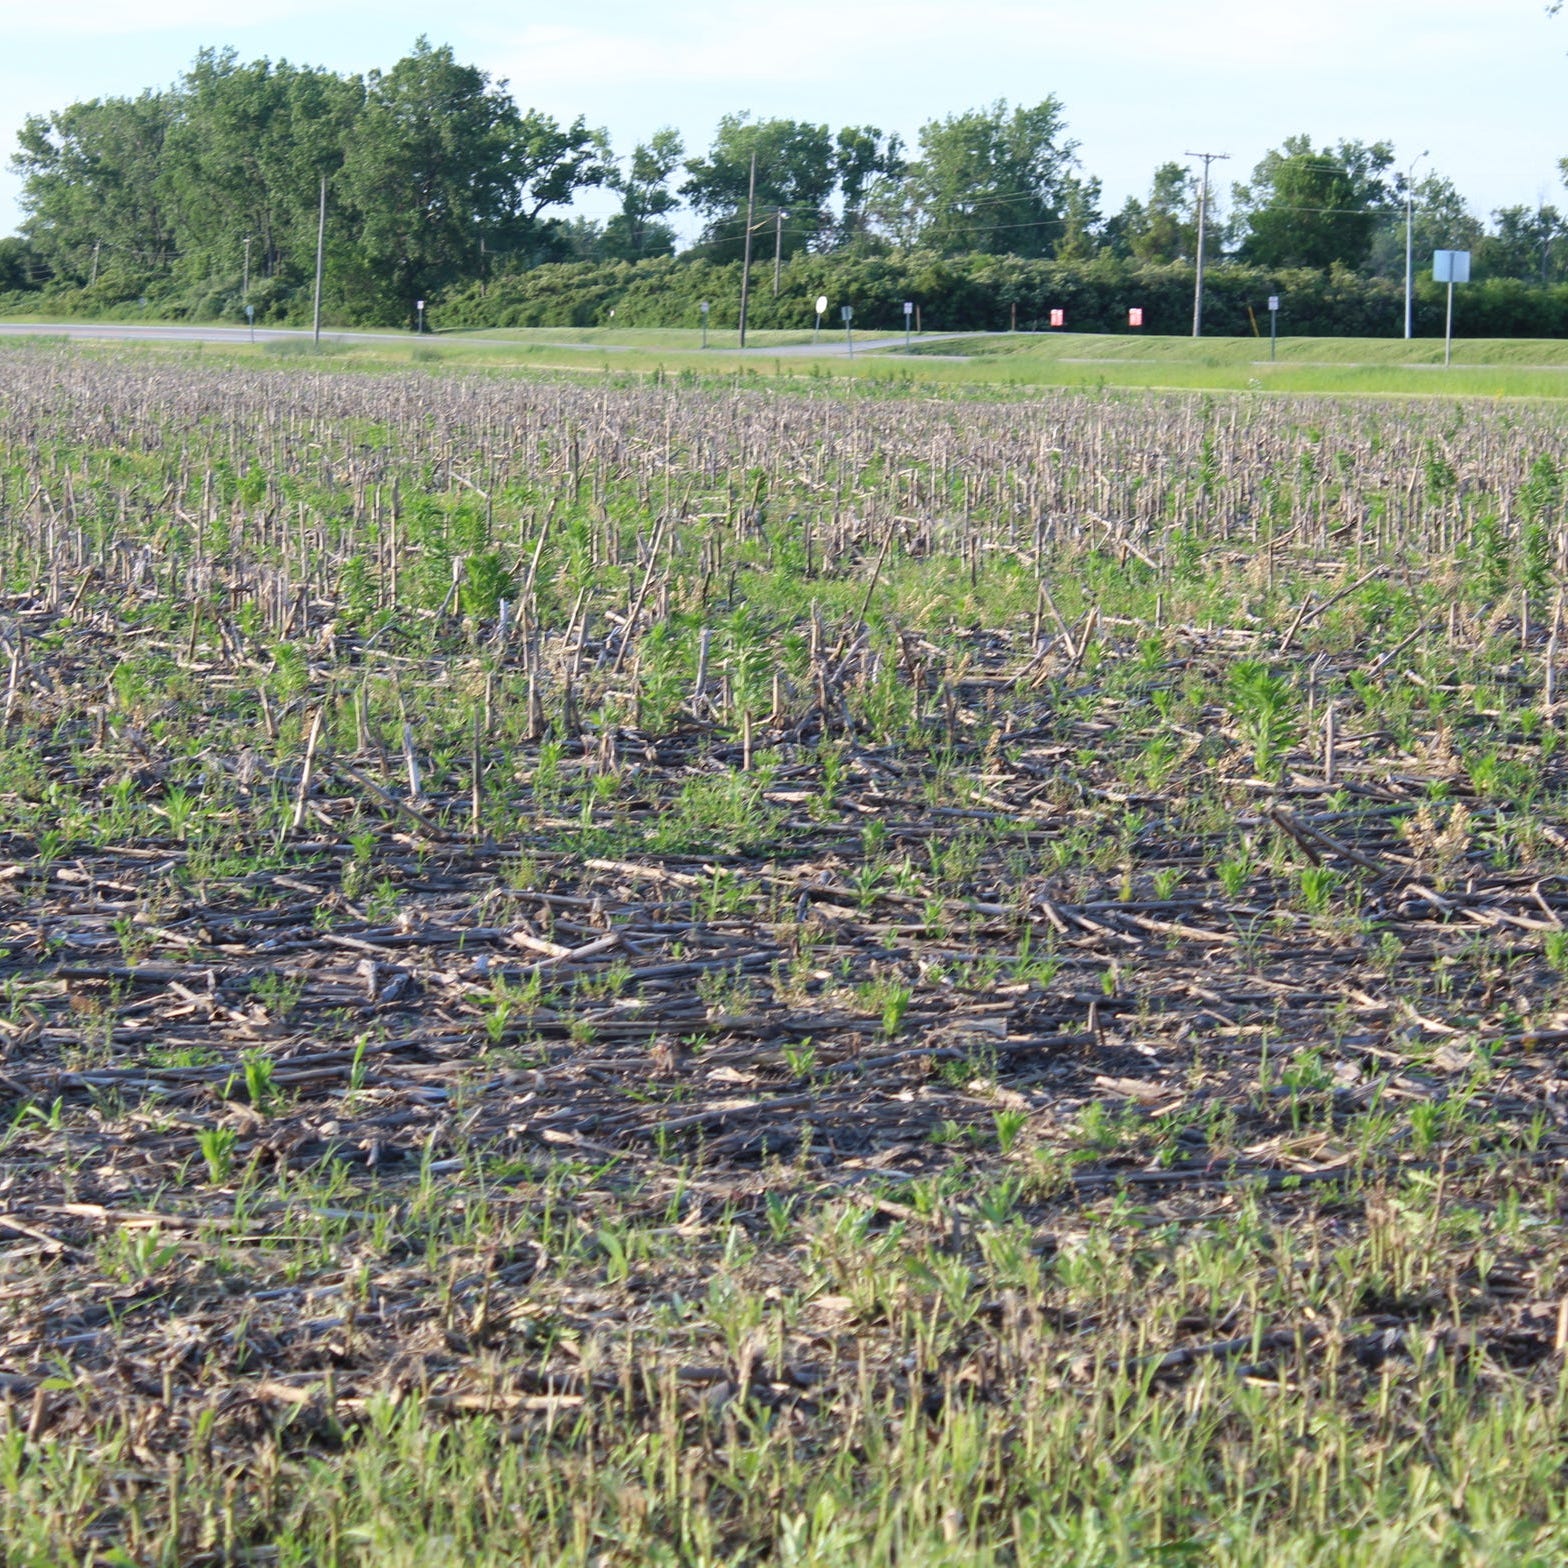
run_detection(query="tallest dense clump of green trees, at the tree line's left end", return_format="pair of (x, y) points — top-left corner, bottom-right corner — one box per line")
(14, 39), (620, 321)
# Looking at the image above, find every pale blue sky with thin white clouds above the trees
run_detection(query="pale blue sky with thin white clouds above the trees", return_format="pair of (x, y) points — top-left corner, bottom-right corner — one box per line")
(0, 0), (1568, 232)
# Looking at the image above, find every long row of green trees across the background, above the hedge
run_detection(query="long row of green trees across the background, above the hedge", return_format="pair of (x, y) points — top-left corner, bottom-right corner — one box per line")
(0, 39), (1568, 325)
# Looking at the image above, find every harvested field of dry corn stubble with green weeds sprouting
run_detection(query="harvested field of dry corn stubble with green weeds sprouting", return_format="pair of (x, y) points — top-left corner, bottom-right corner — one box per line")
(0, 348), (1568, 1568)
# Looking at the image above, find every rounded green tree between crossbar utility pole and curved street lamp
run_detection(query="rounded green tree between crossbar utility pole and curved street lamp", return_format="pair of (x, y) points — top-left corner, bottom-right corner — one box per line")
(1231, 136), (1394, 267)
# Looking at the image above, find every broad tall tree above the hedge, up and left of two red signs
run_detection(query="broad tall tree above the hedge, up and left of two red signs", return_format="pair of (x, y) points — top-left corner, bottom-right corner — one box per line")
(906, 97), (1077, 256)
